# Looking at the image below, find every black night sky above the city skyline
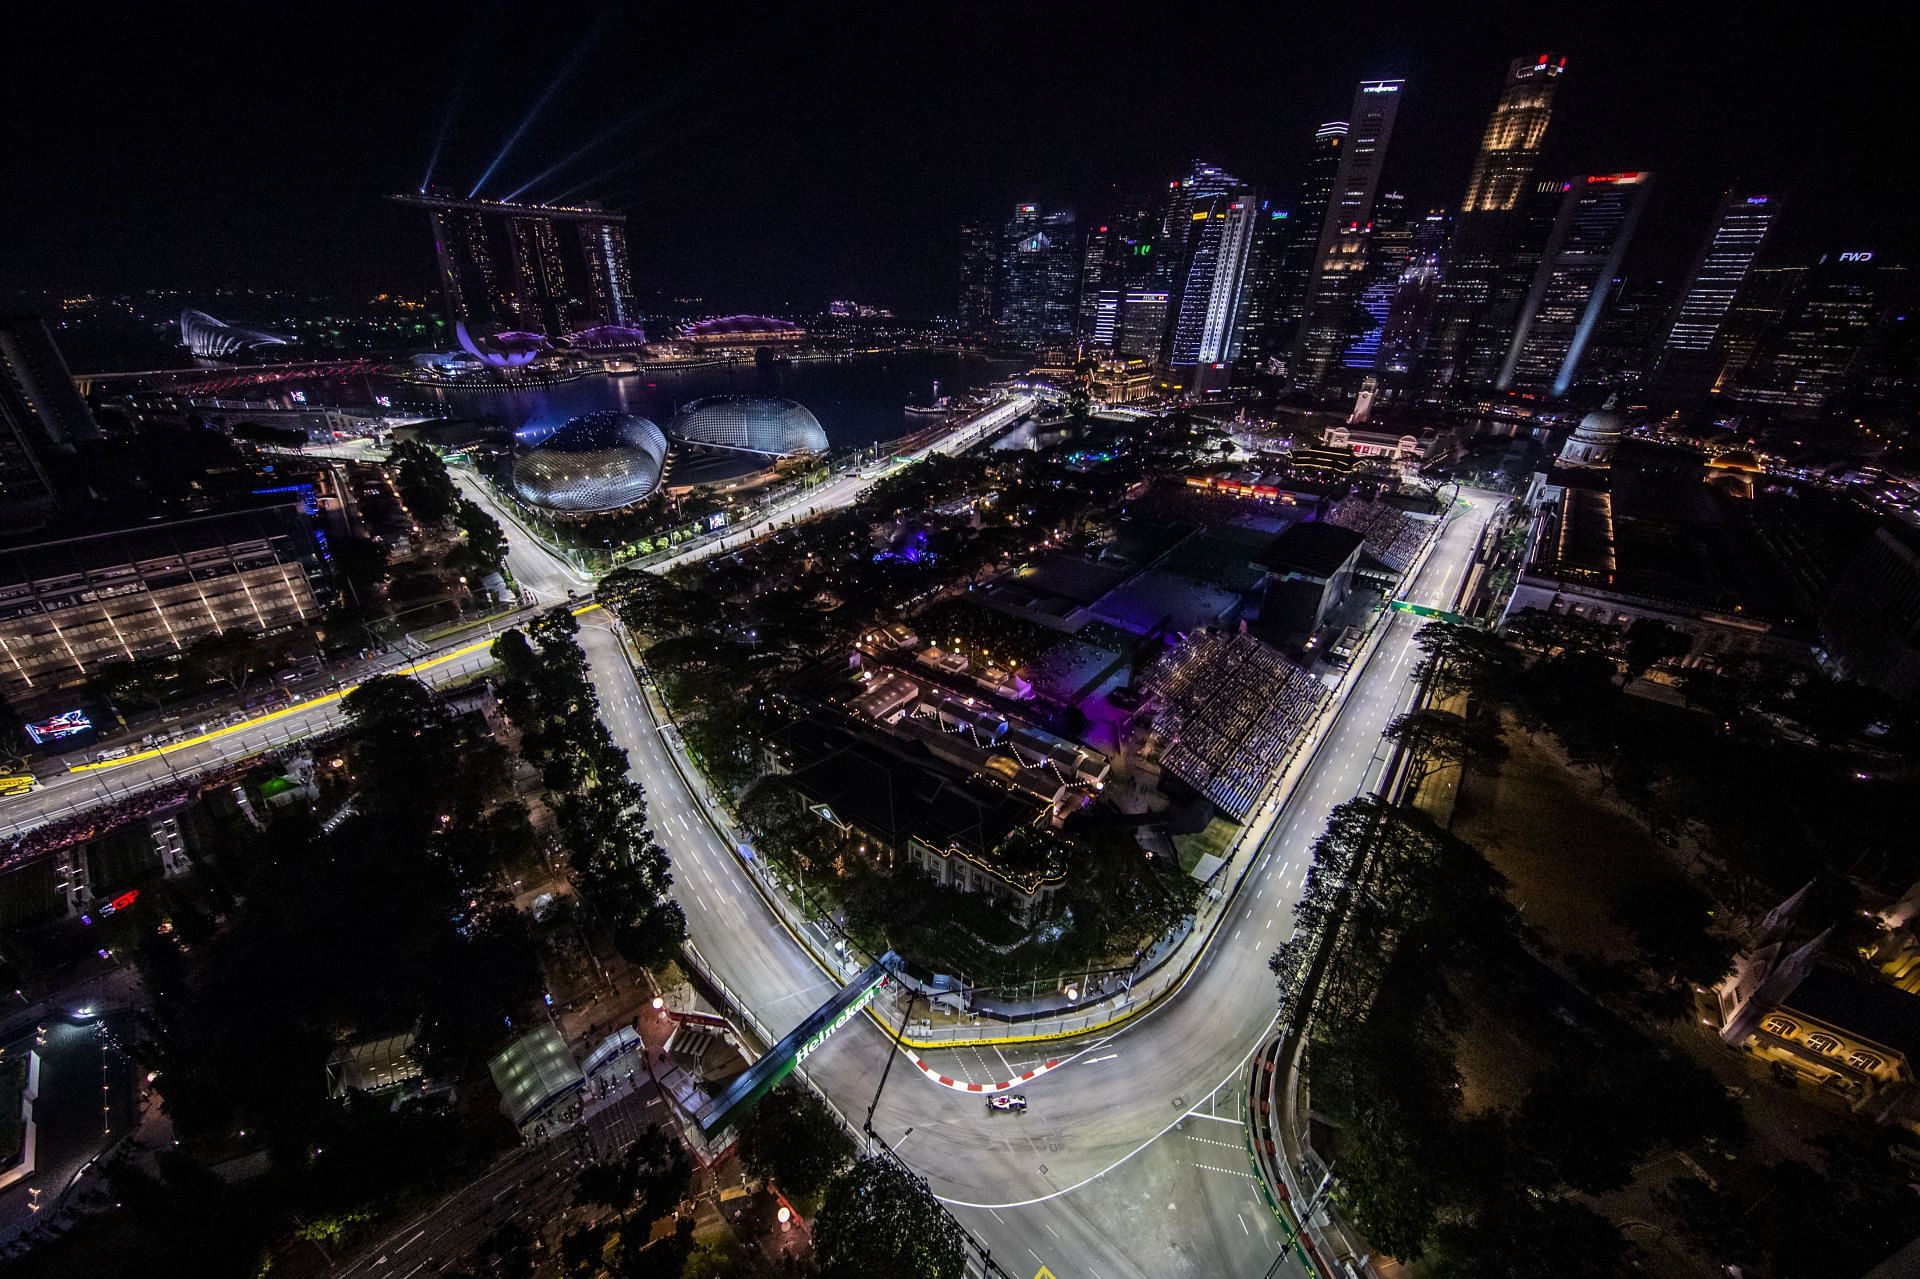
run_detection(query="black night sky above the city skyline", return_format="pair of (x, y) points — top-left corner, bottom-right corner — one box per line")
(0, 0), (1920, 319)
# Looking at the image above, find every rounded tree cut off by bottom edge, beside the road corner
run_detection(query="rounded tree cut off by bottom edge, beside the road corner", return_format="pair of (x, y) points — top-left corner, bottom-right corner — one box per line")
(814, 1154), (966, 1279)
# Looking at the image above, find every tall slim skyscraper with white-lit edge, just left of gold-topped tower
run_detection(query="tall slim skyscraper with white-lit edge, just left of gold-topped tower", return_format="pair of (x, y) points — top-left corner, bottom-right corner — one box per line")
(1292, 81), (1404, 384)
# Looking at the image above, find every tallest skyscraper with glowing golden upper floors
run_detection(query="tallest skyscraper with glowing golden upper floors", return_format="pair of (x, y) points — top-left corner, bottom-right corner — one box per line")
(1423, 54), (1567, 388)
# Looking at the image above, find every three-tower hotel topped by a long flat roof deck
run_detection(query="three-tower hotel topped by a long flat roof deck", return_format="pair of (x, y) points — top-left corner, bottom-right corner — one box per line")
(394, 194), (636, 334)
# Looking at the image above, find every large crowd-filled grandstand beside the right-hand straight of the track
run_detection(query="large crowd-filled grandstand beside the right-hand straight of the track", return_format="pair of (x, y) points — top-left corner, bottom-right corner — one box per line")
(1140, 632), (1327, 820)
